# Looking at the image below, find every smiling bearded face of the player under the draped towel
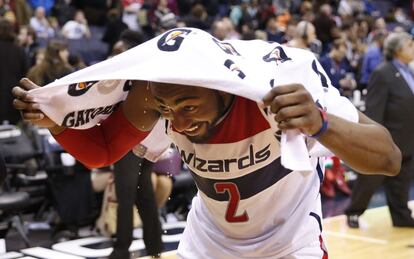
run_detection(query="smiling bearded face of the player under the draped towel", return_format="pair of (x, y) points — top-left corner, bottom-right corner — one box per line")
(150, 82), (233, 143)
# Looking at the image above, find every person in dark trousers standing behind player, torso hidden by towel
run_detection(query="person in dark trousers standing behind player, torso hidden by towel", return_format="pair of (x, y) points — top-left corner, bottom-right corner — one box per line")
(109, 29), (163, 259)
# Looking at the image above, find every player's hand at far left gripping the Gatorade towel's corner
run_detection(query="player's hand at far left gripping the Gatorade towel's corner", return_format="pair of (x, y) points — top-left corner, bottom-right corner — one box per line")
(12, 78), (57, 129)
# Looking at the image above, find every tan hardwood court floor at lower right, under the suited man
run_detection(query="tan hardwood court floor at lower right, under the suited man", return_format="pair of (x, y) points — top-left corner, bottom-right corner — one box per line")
(140, 201), (414, 259)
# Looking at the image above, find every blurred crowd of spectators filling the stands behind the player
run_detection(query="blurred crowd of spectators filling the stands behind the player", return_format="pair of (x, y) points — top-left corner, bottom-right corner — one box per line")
(0, 0), (414, 258)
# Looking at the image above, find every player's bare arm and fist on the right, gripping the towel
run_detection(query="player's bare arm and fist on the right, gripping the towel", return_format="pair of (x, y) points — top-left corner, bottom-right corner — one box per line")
(263, 84), (401, 176)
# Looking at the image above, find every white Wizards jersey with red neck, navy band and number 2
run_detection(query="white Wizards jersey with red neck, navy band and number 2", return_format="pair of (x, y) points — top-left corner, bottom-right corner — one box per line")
(167, 96), (341, 259)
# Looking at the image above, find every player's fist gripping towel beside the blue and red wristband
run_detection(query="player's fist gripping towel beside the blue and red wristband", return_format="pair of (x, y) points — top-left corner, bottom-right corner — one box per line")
(263, 84), (323, 135)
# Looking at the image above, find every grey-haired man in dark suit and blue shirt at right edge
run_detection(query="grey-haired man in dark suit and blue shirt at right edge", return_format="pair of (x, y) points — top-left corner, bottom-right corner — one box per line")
(345, 32), (414, 228)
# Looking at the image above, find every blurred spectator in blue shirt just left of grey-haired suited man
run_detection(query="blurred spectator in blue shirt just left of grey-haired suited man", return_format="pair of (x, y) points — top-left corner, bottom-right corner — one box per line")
(360, 31), (387, 88)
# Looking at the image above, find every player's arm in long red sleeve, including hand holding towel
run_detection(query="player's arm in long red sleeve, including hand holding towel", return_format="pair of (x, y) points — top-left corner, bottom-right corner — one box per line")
(13, 79), (158, 168)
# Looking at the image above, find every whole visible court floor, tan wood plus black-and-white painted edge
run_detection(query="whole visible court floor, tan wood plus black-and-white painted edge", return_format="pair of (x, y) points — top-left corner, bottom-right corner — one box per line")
(0, 196), (414, 259)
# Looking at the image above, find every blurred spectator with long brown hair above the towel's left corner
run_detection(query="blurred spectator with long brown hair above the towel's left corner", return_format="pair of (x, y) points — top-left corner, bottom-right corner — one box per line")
(27, 39), (73, 85)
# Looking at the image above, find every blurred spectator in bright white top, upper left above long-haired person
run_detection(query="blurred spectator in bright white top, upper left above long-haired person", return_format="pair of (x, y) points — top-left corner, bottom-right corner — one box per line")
(62, 10), (91, 40)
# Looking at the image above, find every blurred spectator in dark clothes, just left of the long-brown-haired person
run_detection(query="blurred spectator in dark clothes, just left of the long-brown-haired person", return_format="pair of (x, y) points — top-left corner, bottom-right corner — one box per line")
(17, 26), (39, 67)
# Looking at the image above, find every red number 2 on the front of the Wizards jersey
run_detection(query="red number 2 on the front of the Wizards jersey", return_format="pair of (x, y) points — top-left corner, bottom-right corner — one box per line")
(214, 182), (249, 223)
